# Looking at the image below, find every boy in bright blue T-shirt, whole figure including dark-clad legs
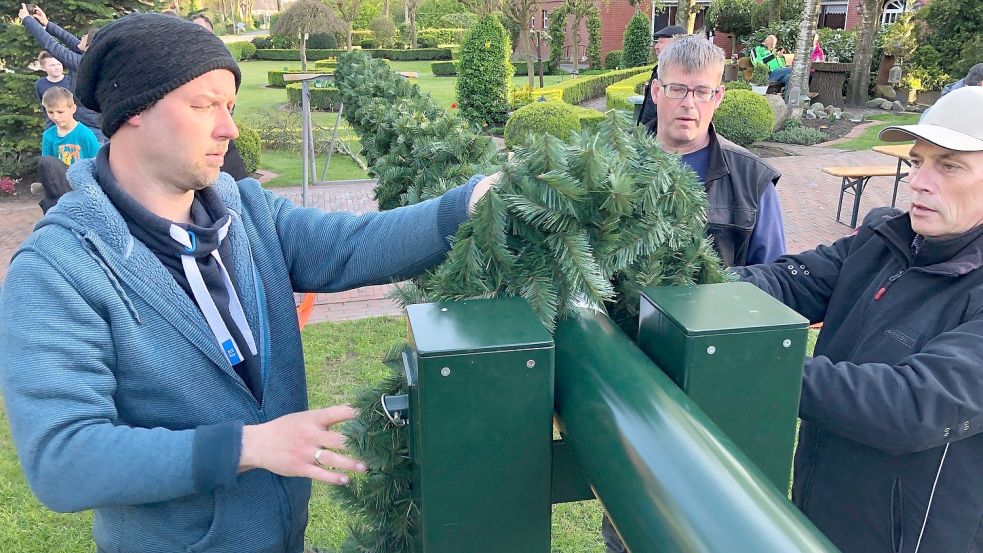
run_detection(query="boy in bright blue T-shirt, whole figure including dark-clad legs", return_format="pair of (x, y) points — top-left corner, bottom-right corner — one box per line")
(38, 86), (99, 213)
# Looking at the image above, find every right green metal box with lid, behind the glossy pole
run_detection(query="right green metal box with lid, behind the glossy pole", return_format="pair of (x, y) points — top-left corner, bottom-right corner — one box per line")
(638, 282), (808, 493)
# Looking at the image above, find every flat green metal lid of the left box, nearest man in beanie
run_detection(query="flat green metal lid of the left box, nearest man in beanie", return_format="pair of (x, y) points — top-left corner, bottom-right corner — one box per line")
(406, 298), (553, 357)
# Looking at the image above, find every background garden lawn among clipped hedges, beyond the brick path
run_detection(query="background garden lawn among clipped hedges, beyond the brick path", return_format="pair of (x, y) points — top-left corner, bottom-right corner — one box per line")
(236, 61), (570, 187)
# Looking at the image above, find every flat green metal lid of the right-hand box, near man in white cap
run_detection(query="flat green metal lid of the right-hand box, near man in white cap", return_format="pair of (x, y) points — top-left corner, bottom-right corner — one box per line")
(642, 282), (809, 335)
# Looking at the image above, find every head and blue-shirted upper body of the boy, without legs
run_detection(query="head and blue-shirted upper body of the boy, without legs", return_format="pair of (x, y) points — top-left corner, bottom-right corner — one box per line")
(41, 86), (99, 166)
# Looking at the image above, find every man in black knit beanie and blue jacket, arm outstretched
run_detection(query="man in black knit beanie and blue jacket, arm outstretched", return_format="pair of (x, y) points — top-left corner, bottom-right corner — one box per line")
(0, 14), (492, 553)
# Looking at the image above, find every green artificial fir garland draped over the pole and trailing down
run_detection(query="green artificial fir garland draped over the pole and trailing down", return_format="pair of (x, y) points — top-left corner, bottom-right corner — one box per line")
(336, 52), (727, 553)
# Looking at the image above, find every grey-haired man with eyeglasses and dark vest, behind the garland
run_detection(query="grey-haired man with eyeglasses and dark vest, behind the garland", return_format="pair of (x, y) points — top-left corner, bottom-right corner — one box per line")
(647, 35), (785, 266)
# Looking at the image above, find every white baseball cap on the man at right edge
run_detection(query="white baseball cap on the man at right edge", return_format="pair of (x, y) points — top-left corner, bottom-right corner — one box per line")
(880, 86), (983, 152)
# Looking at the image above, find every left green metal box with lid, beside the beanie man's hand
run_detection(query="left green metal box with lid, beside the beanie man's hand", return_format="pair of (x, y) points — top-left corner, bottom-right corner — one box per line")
(405, 298), (554, 553)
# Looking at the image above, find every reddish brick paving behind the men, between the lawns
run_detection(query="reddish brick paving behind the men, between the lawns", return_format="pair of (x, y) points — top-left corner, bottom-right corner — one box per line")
(0, 148), (909, 322)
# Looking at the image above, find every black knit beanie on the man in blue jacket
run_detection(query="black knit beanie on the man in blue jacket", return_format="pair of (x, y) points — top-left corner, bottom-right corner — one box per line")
(75, 13), (242, 136)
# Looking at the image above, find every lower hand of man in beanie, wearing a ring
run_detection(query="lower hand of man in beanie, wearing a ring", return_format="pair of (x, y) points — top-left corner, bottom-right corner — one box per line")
(239, 405), (366, 485)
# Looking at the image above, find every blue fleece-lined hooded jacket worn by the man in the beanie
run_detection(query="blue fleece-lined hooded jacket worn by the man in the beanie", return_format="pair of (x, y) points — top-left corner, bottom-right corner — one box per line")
(0, 160), (477, 553)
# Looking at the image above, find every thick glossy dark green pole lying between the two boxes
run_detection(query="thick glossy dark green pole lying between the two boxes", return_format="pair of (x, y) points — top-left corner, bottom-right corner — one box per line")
(554, 310), (837, 553)
